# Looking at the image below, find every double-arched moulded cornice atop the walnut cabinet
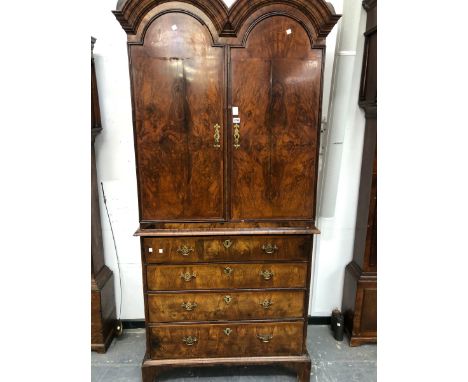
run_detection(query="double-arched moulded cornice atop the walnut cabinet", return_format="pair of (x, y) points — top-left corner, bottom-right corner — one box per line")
(113, 0), (341, 38)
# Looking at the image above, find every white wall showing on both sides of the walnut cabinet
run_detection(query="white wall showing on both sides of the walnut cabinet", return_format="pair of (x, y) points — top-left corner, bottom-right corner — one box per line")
(91, 0), (365, 319)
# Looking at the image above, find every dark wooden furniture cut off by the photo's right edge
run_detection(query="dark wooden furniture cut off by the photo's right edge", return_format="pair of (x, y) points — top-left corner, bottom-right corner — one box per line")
(342, 0), (377, 346)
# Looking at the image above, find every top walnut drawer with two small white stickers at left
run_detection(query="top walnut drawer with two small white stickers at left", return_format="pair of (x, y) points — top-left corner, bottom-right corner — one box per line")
(143, 235), (312, 263)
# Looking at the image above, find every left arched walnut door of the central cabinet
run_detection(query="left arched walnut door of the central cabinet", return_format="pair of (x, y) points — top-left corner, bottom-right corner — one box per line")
(130, 13), (225, 221)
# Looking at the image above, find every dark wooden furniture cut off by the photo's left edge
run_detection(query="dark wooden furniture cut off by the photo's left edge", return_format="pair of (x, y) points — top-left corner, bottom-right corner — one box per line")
(91, 37), (116, 353)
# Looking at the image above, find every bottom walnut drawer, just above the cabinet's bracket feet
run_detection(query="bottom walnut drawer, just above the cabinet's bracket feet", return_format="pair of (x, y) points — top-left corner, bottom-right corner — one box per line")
(149, 322), (304, 359)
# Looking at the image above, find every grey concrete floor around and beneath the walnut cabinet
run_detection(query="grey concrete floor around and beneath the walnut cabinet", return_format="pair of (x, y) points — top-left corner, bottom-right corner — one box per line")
(91, 325), (377, 382)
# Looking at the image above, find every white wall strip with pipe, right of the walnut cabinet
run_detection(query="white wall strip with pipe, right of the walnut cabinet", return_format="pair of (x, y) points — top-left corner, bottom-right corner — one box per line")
(309, 0), (366, 316)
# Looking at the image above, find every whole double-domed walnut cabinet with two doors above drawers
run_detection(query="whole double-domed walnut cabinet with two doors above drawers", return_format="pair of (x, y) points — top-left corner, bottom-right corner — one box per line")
(114, 0), (340, 382)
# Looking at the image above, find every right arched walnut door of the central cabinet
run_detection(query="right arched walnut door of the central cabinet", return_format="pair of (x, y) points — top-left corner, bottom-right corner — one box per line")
(231, 16), (322, 220)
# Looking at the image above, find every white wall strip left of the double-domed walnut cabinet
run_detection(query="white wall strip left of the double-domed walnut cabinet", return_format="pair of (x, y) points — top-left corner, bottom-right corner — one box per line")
(91, 0), (144, 319)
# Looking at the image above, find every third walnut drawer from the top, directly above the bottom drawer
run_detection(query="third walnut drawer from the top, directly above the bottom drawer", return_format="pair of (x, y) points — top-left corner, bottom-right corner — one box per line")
(148, 290), (305, 322)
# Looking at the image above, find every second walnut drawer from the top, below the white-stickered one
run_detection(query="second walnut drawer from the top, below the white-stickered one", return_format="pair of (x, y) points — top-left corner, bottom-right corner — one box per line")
(146, 263), (307, 291)
